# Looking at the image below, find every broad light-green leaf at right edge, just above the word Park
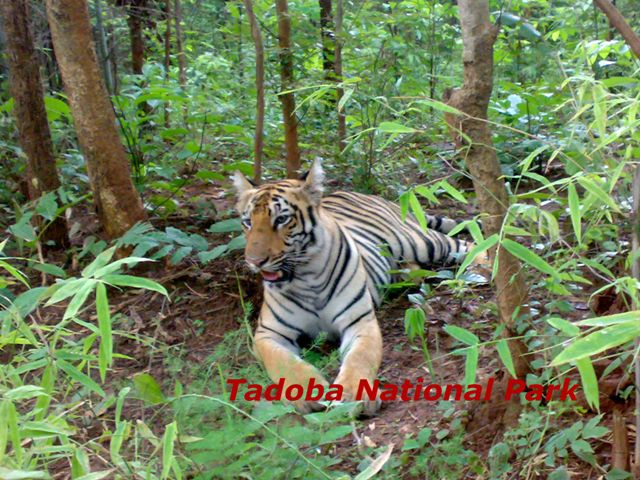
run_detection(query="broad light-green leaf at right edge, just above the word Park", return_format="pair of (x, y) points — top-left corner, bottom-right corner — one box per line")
(551, 321), (640, 366)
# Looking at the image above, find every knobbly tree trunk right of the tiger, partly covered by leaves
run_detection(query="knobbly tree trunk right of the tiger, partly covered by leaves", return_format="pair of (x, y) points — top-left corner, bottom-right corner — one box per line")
(447, 0), (531, 425)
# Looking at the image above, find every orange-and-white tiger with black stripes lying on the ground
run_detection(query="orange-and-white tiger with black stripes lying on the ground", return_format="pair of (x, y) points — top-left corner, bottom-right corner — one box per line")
(233, 160), (472, 416)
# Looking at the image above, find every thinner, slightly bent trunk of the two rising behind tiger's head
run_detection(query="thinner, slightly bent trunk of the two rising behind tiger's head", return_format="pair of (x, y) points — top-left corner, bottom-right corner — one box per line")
(244, 0), (264, 184)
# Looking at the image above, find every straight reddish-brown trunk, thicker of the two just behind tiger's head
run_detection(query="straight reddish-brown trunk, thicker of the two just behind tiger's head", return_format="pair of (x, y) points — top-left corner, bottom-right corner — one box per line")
(276, 0), (300, 178)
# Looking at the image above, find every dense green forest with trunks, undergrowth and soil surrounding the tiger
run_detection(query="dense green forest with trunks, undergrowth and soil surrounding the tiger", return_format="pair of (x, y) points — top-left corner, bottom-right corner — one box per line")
(0, 0), (640, 480)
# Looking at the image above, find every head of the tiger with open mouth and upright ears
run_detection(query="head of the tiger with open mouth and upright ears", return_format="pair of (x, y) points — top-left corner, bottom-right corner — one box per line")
(233, 160), (324, 283)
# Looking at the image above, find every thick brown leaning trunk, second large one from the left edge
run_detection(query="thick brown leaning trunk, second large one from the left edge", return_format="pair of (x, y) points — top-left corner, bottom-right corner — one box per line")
(46, 0), (146, 238)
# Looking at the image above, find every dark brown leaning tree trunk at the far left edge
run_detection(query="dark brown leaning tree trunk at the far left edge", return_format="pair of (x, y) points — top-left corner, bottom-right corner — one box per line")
(0, 0), (69, 247)
